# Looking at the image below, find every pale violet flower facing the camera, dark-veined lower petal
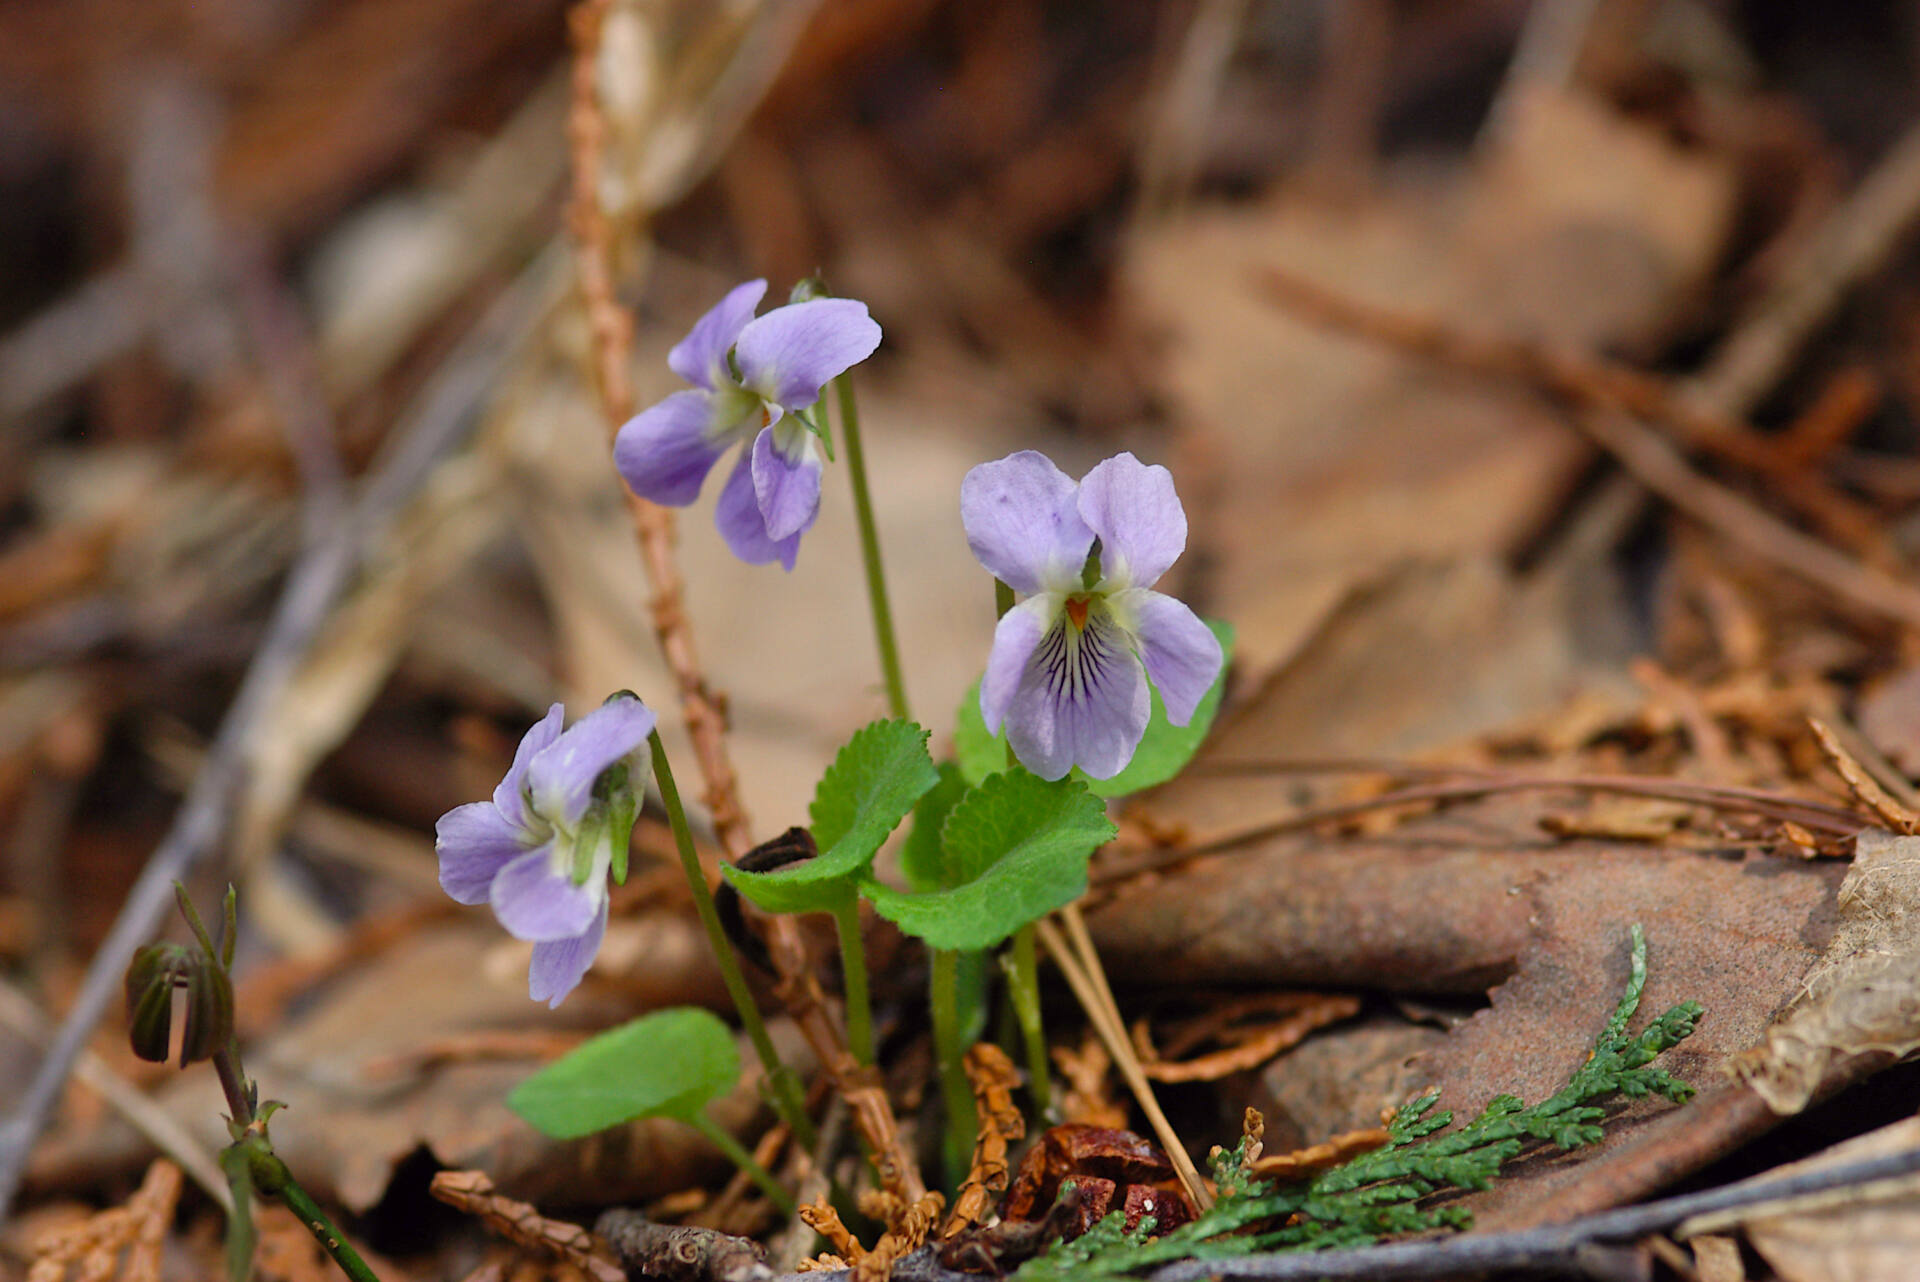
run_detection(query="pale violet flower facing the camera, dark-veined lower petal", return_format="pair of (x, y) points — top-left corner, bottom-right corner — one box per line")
(960, 449), (1221, 779)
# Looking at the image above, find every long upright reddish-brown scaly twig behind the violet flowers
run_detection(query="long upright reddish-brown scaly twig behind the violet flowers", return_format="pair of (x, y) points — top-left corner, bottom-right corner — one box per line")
(566, 0), (925, 1205)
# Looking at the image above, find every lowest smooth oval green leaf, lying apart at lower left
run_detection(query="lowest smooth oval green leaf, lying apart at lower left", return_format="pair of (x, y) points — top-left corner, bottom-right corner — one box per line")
(507, 1006), (739, 1140)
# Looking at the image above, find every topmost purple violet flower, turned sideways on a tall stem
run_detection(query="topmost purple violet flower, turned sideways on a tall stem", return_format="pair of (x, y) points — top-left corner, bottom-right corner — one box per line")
(612, 280), (879, 570)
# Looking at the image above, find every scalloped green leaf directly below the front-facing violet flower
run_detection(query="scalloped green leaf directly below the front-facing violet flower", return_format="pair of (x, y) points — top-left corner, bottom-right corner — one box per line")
(860, 770), (1117, 948)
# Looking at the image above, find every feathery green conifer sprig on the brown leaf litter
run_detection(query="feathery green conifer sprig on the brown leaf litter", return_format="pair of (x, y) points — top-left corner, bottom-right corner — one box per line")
(1016, 925), (1701, 1282)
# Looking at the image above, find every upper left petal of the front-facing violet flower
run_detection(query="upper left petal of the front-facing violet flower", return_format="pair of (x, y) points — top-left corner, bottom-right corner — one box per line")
(960, 449), (1092, 593)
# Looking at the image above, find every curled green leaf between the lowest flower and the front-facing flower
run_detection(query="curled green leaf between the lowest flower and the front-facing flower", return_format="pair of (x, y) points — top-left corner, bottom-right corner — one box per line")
(720, 722), (939, 912)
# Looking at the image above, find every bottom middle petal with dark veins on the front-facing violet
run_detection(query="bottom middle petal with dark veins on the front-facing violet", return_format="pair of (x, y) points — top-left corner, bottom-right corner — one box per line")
(1006, 620), (1152, 779)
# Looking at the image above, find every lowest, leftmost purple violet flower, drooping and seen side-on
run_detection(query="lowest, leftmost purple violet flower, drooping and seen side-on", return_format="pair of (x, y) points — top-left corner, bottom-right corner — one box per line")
(434, 693), (653, 1006)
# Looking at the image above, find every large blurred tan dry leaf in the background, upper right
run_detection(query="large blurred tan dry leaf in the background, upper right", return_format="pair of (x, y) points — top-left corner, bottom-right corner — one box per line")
(1129, 84), (1734, 674)
